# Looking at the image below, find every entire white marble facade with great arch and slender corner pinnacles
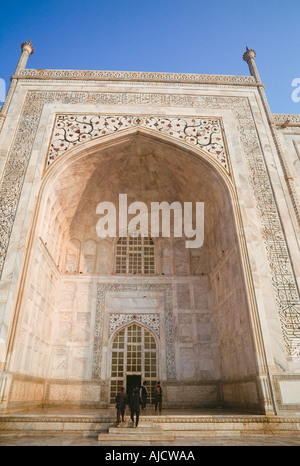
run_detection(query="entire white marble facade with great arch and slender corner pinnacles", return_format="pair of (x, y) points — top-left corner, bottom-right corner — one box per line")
(0, 43), (300, 414)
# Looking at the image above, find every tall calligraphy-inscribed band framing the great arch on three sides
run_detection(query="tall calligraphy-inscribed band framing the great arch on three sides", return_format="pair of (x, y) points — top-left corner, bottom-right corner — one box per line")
(0, 89), (300, 357)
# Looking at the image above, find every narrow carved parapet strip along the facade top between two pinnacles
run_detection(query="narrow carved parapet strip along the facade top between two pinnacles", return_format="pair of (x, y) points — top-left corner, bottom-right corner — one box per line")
(13, 69), (264, 87)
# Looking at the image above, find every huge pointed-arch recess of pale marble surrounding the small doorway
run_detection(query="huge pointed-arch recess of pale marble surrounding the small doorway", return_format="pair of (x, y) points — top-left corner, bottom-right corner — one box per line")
(7, 129), (264, 412)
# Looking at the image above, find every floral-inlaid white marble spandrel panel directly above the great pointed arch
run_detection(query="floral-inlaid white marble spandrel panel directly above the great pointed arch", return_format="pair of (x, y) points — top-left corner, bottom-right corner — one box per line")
(46, 114), (230, 174)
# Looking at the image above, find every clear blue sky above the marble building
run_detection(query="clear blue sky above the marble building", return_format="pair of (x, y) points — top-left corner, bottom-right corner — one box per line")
(0, 0), (300, 114)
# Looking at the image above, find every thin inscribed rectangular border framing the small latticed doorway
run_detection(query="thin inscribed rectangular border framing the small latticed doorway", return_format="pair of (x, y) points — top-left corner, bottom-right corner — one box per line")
(92, 283), (176, 379)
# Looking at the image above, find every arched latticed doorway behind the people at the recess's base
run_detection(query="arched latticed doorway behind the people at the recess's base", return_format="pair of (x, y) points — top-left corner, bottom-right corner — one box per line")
(110, 323), (159, 403)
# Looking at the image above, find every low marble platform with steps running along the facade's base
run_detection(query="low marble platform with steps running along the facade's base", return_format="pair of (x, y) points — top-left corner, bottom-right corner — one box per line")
(0, 407), (300, 442)
